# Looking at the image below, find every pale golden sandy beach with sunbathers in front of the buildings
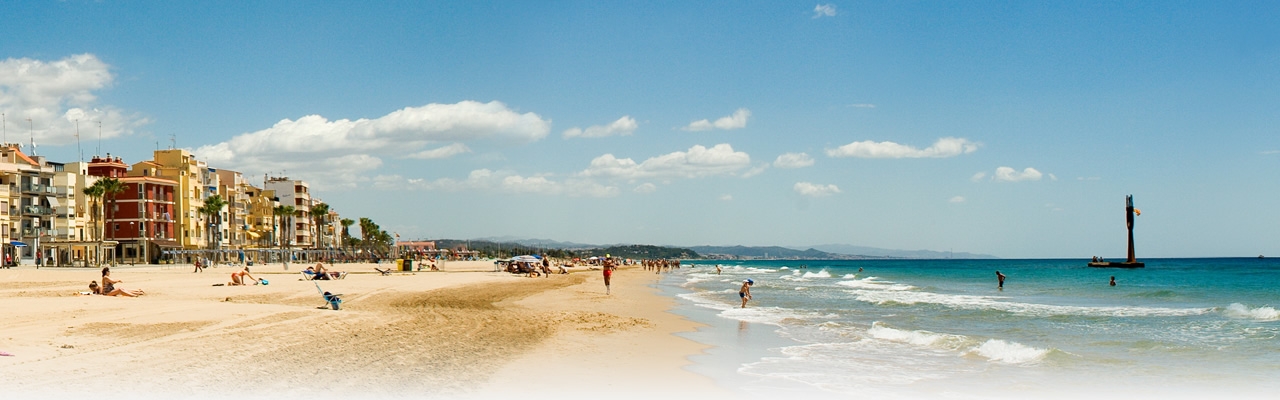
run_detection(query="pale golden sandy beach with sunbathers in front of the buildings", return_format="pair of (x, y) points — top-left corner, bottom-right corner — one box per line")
(0, 262), (730, 399)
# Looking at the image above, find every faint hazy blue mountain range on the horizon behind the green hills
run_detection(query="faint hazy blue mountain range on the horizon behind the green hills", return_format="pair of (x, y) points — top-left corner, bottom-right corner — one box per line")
(477, 236), (998, 260)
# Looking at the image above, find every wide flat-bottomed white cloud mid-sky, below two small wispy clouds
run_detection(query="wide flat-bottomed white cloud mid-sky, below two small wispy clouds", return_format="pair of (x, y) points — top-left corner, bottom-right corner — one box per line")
(580, 144), (751, 179)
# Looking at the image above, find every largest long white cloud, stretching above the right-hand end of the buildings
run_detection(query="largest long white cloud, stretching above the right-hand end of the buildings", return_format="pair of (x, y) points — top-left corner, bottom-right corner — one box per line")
(193, 101), (550, 186)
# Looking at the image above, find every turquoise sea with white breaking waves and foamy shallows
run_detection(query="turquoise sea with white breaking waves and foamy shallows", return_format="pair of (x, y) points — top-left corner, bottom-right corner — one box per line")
(658, 258), (1280, 399)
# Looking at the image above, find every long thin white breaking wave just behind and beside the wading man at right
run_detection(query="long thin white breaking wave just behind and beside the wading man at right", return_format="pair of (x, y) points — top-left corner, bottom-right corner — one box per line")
(840, 288), (1213, 317)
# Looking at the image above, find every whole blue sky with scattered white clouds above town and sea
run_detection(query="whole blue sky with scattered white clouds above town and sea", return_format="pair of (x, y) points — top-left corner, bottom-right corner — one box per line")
(0, 1), (1280, 258)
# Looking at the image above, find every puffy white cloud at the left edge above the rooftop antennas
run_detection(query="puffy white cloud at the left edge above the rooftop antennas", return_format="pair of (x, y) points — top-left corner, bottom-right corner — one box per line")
(0, 54), (150, 145)
